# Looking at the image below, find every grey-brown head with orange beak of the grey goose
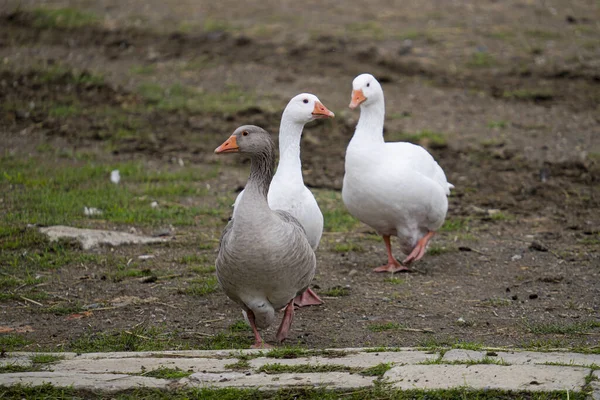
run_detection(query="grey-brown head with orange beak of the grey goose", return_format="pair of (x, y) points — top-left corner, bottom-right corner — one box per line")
(215, 125), (274, 155)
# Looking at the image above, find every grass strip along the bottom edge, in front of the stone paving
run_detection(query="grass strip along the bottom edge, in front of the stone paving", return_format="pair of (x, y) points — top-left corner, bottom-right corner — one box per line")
(1, 384), (587, 400)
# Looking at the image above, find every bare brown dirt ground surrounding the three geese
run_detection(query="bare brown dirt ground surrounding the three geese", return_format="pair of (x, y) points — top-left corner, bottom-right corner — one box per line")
(0, 0), (600, 351)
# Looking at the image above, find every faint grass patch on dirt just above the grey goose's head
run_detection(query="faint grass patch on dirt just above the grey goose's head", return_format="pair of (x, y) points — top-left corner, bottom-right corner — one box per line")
(138, 83), (258, 113)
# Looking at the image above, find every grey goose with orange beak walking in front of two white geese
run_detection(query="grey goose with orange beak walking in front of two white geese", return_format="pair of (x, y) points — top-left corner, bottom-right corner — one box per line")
(215, 125), (316, 347)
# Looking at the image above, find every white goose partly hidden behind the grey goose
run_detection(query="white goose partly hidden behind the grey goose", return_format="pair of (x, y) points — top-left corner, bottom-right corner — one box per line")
(233, 93), (334, 307)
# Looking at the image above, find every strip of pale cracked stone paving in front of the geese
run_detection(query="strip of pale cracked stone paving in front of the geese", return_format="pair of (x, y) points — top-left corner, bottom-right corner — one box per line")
(0, 349), (600, 394)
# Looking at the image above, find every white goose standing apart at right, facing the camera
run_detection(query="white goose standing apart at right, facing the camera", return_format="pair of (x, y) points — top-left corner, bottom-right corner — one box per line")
(342, 74), (454, 272)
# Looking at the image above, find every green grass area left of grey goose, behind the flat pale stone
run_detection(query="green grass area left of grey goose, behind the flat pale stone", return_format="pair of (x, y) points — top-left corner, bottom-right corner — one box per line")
(0, 157), (221, 230)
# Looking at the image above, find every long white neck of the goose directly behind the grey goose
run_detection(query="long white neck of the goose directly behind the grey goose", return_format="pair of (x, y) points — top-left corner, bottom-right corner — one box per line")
(274, 111), (304, 183)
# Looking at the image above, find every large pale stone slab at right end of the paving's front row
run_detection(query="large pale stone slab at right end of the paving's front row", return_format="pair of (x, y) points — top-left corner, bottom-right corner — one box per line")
(384, 364), (590, 391)
